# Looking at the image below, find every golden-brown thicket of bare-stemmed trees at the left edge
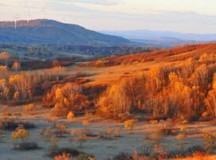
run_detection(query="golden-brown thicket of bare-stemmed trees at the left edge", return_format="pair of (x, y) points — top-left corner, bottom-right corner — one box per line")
(0, 65), (64, 105)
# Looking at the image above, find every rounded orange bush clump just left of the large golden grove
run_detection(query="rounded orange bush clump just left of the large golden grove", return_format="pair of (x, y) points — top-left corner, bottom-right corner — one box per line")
(43, 83), (88, 117)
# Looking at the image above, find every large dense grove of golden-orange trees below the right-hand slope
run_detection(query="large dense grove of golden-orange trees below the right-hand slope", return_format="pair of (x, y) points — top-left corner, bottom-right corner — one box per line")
(96, 59), (216, 122)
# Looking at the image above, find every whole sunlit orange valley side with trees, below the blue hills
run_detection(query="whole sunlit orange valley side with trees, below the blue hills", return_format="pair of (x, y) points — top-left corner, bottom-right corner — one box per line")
(0, 43), (216, 160)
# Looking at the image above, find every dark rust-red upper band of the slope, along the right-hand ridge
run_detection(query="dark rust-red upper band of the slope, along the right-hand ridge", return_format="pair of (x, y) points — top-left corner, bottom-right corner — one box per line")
(97, 43), (216, 65)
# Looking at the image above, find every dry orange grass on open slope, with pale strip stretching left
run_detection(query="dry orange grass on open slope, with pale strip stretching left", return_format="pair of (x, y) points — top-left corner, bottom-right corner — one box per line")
(68, 43), (216, 86)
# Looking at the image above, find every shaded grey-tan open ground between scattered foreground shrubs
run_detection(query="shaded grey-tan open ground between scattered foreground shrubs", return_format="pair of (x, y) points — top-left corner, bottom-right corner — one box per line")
(0, 107), (216, 160)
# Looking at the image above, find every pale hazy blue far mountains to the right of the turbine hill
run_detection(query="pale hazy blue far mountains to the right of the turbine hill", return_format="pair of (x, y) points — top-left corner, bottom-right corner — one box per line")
(102, 30), (216, 47)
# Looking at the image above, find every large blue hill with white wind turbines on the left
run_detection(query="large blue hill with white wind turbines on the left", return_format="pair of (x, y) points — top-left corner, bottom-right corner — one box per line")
(0, 19), (130, 46)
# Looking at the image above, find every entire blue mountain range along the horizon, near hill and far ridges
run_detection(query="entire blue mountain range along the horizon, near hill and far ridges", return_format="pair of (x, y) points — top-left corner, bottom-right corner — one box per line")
(0, 19), (216, 48)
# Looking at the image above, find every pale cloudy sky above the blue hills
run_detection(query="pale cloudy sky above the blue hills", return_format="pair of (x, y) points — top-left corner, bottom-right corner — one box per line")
(0, 0), (216, 34)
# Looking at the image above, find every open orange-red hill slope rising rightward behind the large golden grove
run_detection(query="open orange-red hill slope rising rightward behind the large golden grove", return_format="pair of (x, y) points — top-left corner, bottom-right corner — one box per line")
(82, 43), (216, 85)
